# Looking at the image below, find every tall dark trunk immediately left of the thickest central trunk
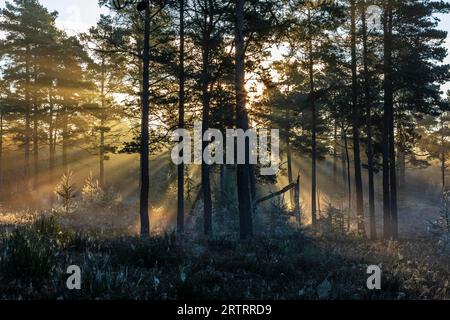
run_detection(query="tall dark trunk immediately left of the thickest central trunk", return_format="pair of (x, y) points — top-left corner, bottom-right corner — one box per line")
(202, 0), (213, 236)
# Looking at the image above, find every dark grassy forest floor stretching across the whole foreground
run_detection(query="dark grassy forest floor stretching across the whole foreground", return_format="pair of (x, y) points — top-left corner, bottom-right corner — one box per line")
(0, 212), (450, 299)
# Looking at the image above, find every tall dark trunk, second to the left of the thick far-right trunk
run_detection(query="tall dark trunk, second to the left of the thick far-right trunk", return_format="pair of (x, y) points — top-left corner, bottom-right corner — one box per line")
(350, 0), (366, 235)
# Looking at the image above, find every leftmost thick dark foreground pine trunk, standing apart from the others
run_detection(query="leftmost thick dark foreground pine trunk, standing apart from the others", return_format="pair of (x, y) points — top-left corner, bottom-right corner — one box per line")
(139, 0), (150, 237)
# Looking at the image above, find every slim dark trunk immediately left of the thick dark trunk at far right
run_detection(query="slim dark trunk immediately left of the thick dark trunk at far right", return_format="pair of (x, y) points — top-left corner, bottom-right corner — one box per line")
(361, 0), (377, 240)
